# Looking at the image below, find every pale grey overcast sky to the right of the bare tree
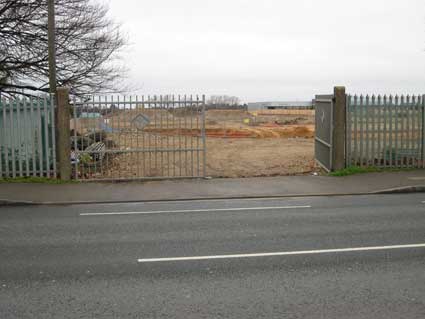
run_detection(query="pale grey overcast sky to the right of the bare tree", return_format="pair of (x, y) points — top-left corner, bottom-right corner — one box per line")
(108, 0), (425, 101)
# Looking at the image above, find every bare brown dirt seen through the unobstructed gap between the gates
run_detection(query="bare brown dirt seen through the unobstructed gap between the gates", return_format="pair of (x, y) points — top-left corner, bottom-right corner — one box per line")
(202, 110), (314, 177)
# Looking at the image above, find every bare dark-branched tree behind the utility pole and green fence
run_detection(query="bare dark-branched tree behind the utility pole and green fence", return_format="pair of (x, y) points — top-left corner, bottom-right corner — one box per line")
(0, 0), (126, 95)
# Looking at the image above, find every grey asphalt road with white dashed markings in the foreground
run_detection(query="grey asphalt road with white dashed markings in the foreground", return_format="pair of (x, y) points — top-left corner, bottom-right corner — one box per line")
(0, 194), (425, 319)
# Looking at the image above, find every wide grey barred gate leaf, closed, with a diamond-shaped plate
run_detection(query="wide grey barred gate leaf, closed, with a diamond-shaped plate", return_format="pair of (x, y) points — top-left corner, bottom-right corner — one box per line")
(70, 95), (206, 180)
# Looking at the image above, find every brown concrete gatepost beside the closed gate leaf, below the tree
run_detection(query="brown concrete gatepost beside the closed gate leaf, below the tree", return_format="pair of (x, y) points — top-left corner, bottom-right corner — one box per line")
(56, 87), (71, 181)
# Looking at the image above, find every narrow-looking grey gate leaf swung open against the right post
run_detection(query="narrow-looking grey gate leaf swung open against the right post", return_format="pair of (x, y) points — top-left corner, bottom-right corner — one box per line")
(314, 95), (334, 171)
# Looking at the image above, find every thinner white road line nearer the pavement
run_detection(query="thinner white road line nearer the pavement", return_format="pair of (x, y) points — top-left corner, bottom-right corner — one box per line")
(80, 205), (311, 216)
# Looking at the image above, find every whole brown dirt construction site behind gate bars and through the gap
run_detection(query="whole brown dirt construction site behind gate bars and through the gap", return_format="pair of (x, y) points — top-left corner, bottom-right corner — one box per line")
(71, 108), (315, 178)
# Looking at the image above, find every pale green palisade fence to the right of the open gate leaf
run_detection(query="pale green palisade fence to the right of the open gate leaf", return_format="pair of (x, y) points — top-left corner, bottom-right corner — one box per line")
(346, 95), (425, 168)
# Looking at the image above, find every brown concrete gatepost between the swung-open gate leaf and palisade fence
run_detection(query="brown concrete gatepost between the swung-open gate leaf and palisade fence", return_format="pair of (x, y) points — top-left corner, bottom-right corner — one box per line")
(332, 86), (347, 170)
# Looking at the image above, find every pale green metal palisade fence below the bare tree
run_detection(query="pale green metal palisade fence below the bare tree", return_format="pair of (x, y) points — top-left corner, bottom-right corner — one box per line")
(0, 96), (56, 178)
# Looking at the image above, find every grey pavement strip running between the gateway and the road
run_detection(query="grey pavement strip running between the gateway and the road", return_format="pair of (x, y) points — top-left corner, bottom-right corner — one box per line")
(0, 170), (425, 204)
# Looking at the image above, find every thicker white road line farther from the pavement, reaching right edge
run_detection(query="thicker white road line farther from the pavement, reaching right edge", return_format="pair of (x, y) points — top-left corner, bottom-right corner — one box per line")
(137, 243), (425, 263)
